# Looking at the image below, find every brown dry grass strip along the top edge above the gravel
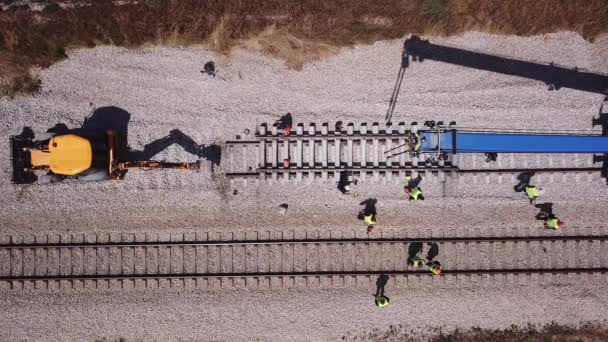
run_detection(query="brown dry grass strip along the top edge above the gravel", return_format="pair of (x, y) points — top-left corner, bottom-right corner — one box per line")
(0, 0), (608, 94)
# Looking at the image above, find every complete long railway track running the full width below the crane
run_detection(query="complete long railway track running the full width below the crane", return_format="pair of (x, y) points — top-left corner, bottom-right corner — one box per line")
(0, 234), (608, 289)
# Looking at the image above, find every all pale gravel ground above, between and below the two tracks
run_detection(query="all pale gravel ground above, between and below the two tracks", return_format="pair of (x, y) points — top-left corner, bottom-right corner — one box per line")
(0, 33), (608, 340)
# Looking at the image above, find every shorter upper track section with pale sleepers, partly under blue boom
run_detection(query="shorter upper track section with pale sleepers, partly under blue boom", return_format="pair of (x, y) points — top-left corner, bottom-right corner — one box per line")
(222, 122), (602, 182)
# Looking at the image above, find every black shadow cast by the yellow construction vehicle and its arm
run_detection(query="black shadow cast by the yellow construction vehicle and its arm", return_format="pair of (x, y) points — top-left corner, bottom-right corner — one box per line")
(48, 106), (221, 165)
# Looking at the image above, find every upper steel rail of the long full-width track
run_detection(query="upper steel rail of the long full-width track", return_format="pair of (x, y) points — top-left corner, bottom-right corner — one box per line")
(0, 235), (608, 249)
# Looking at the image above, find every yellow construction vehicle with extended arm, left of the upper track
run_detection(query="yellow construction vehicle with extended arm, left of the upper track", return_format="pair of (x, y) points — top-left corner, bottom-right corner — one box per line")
(11, 129), (200, 184)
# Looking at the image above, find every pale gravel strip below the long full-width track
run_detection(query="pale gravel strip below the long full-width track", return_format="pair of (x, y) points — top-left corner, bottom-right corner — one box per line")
(0, 281), (608, 341)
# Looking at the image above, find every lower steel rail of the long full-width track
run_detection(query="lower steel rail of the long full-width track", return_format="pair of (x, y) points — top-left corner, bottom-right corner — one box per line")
(0, 267), (608, 281)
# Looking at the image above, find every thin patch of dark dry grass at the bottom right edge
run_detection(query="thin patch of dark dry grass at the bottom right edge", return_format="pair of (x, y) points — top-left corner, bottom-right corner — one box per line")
(342, 323), (608, 342)
